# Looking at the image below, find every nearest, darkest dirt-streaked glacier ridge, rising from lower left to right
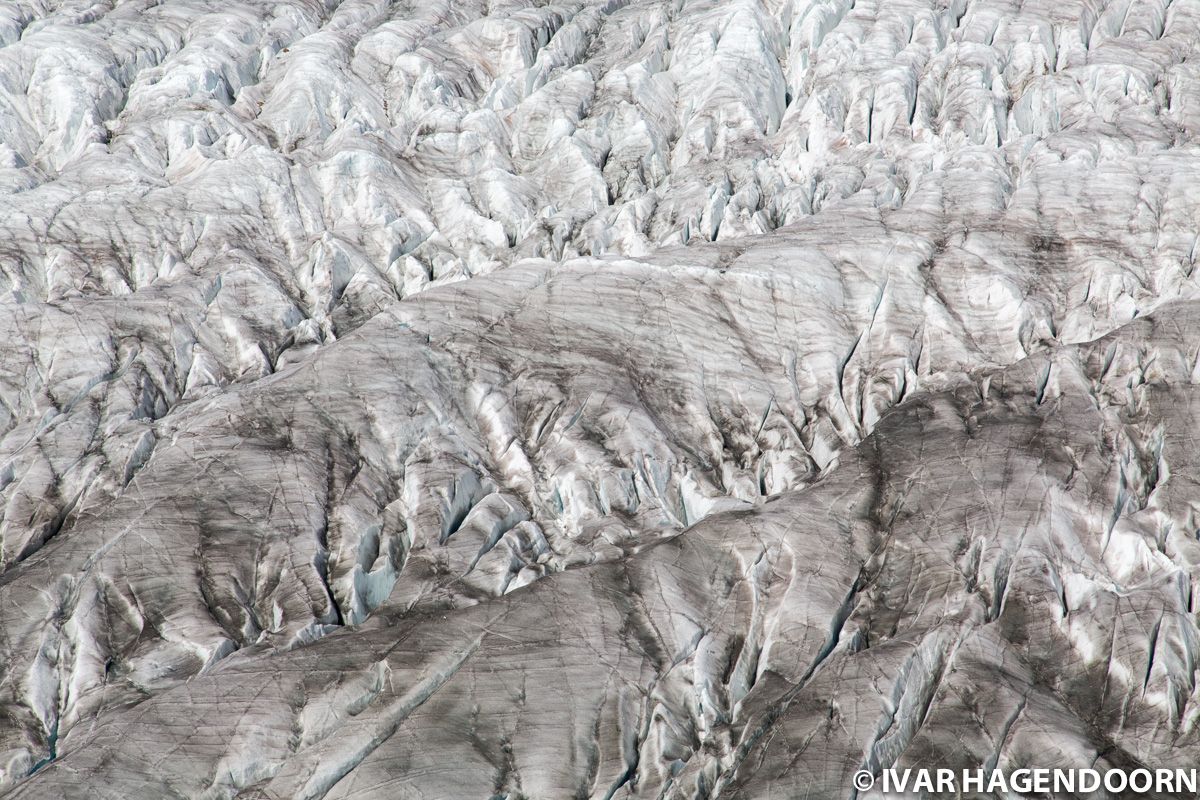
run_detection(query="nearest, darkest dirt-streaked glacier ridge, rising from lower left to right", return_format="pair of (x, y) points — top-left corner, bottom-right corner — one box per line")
(11, 302), (1200, 799)
